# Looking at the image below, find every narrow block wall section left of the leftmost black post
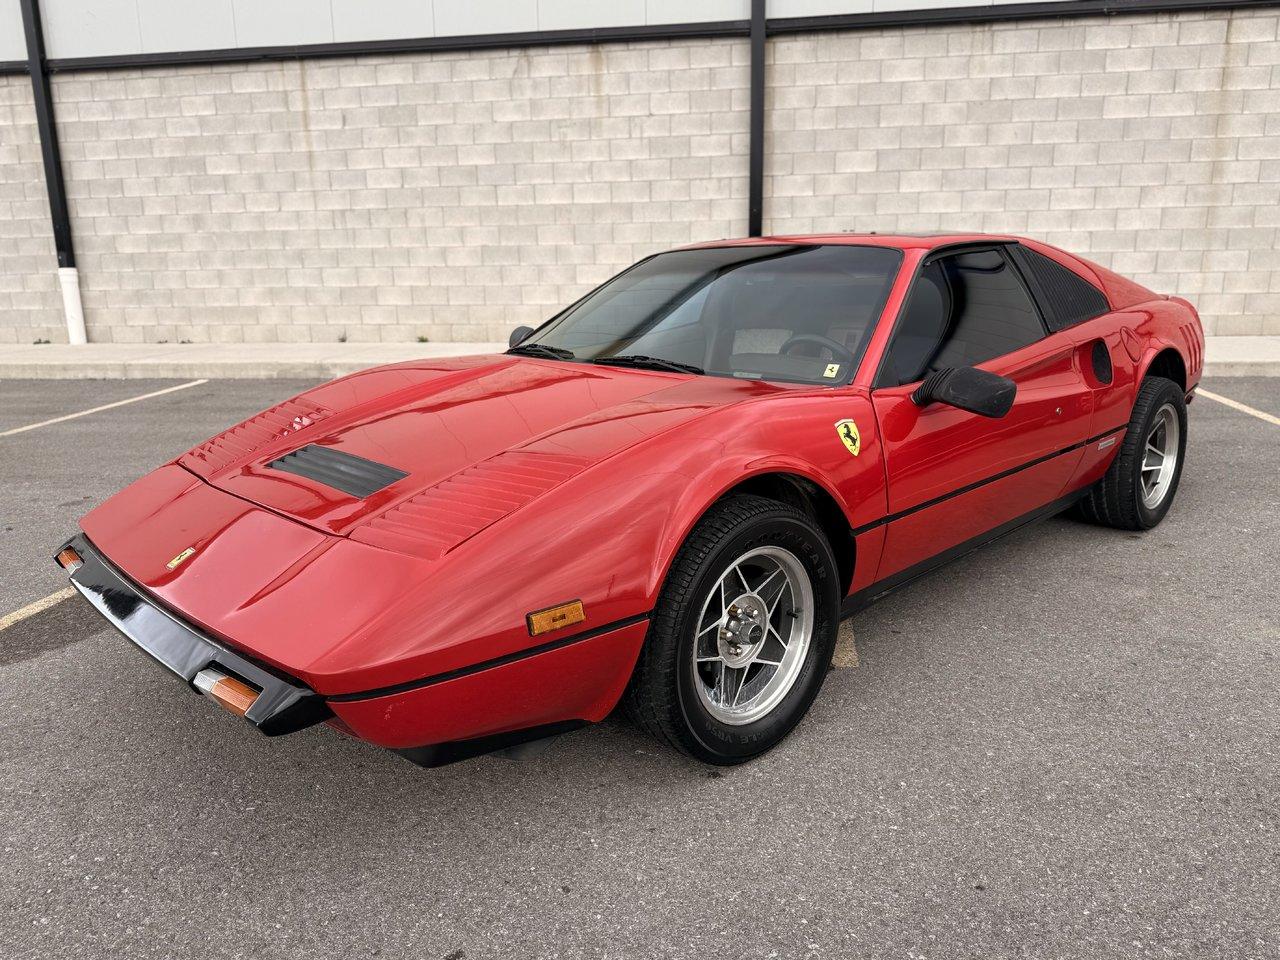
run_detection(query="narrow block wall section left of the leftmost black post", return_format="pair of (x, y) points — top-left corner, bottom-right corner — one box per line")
(0, 77), (67, 344)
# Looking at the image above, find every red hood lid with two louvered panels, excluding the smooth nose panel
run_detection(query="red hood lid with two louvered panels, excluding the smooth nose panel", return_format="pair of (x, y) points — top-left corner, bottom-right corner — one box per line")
(179, 356), (776, 559)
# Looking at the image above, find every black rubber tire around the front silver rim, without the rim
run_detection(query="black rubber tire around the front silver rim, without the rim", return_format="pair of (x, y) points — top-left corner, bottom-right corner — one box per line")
(623, 495), (840, 765)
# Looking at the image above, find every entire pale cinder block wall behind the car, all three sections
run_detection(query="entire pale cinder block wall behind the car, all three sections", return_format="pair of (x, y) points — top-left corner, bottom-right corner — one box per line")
(0, 9), (1280, 343)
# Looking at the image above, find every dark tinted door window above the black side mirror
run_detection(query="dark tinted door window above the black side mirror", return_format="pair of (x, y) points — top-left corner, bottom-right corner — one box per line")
(881, 250), (1044, 387)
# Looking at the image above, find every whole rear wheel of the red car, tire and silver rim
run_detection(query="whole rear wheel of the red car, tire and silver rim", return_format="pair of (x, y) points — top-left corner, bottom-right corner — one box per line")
(1076, 376), (1187, 530)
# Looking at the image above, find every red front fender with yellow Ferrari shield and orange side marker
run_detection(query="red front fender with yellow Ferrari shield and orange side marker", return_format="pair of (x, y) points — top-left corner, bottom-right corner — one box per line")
(308, 392), (884, 692)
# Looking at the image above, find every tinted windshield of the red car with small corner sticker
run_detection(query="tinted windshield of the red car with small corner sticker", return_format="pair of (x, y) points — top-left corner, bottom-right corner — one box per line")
(515, 244), (902, 385)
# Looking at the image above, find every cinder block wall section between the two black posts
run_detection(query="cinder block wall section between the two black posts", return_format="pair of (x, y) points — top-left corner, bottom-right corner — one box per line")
(54, 41), (749, 342)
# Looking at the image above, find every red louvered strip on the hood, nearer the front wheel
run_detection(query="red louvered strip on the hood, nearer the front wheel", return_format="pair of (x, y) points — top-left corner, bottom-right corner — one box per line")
(351, 449), (590, 559)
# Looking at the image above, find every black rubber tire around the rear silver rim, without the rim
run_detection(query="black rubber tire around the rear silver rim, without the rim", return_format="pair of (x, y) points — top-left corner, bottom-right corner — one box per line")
(1075, 376), (1187, 530)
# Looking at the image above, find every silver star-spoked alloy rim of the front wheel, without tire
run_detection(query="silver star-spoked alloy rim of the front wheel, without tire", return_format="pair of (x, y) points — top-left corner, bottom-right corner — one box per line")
(692, 547), (814, 726)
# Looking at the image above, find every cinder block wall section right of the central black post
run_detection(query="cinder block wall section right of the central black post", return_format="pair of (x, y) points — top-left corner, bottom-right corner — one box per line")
(764, 9), (1280, 334)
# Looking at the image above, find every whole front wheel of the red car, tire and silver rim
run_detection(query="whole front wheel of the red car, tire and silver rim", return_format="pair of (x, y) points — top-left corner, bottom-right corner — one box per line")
(626, 497), (838, 764)
